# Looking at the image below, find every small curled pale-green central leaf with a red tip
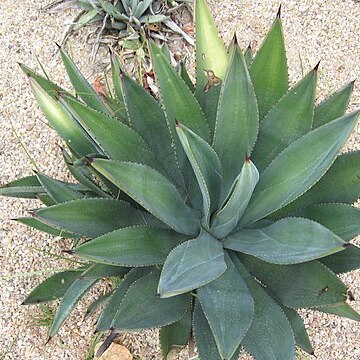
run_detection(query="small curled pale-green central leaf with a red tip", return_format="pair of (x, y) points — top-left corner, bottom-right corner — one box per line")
(211, 159), (259, 239)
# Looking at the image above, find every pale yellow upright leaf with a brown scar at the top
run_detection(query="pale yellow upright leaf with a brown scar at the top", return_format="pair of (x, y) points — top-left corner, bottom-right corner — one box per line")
(195, 0), (229, 135)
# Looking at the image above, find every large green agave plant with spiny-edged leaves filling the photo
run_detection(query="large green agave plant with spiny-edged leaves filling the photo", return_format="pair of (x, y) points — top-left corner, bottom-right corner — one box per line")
(1, 0), (360, 360)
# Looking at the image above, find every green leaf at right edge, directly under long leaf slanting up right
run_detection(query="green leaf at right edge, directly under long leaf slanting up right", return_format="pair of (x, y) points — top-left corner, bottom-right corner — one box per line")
(274, 149), (360, 217)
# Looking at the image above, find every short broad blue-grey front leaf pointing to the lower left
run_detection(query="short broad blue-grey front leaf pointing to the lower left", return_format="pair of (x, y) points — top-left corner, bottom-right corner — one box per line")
(157, 230), (226, 298)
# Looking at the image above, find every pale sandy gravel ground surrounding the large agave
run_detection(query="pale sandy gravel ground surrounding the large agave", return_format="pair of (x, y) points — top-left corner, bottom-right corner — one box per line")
(0, 0), (360, 360)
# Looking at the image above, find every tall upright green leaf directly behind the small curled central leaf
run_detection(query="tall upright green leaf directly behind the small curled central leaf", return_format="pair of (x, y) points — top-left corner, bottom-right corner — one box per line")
(213, 38), (259, 194)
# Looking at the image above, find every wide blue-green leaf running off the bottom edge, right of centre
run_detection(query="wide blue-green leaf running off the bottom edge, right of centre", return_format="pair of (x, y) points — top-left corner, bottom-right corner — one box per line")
(232, 256), (295, 360)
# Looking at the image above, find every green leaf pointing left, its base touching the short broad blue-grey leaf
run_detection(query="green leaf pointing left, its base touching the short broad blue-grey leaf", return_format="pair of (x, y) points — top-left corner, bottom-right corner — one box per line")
(74, 226), (188, 266)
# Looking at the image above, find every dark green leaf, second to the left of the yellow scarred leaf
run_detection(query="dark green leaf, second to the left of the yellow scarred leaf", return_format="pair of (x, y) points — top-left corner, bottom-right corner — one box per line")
(120, 74), (185, 188)
